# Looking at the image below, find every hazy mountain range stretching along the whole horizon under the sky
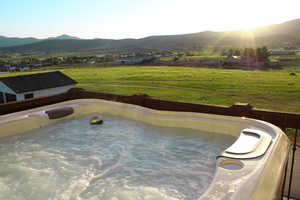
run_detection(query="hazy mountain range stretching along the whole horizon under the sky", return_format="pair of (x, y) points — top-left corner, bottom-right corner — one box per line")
(0, 19), (300, 53)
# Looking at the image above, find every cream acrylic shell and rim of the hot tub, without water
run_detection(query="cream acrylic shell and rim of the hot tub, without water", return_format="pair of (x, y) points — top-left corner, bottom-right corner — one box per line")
(0, 99), (289, 200)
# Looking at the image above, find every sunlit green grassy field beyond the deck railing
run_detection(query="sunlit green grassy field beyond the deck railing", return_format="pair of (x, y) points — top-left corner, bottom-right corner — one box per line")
(0, 66), (300, 112)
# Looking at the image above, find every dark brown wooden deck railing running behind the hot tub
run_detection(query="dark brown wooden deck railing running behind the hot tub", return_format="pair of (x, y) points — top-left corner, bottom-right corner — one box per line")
(0, 89), (300, 199)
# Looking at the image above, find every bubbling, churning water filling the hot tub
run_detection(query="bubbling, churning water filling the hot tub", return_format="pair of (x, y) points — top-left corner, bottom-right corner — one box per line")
(0, 116), (234, 200)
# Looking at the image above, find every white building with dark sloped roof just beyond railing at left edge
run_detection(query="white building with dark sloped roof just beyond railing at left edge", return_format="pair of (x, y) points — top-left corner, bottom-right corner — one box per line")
(0, 71), (77, 103)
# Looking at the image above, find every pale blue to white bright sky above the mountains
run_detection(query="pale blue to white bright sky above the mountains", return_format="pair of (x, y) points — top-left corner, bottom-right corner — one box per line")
(0, 0), (300, 39)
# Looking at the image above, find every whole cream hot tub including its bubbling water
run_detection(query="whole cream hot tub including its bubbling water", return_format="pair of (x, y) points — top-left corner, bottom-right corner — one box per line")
(0, 99), (289, 200)
